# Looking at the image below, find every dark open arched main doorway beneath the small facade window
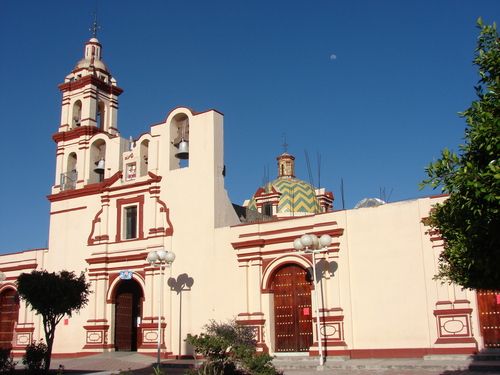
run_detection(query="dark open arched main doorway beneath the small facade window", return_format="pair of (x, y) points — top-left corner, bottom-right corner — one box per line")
(115, 280), (142, 351)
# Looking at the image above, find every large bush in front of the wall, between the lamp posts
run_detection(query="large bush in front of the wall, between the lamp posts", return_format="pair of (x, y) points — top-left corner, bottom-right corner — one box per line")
(186, 320), (280, 375)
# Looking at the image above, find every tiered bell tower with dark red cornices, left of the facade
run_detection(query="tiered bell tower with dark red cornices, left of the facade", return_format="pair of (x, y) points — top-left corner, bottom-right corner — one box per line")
(52, 26), (123, 191)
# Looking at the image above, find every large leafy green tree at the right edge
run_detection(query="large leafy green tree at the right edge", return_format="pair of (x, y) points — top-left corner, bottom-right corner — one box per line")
(422, 19), (500, 290)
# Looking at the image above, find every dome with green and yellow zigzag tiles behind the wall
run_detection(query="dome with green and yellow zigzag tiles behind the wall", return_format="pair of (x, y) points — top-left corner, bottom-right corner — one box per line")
(247, 152), (321, 214)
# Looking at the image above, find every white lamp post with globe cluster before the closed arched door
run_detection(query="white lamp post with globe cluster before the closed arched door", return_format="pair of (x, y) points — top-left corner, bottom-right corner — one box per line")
(293, 234), (332, 366)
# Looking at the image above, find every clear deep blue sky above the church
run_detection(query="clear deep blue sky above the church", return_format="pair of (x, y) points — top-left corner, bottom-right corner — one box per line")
(0, 0), (500, 253)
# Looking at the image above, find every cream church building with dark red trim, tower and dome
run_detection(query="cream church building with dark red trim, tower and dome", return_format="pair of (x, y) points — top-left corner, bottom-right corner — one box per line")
(0, 38), (499, 358)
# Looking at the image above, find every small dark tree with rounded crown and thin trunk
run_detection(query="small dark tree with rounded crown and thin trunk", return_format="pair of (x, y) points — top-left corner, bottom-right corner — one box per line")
(17, 271), (90, 371)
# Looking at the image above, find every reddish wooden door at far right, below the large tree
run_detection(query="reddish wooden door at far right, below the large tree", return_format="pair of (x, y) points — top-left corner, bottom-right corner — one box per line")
(477, 290), (500, 349)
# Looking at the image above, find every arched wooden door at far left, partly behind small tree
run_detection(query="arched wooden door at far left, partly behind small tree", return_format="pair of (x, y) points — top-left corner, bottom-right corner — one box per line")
(0, 289), (19, 349)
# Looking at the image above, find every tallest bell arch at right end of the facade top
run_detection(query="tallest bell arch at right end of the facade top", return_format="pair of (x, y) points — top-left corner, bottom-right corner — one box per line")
(170, 113), (189, 169)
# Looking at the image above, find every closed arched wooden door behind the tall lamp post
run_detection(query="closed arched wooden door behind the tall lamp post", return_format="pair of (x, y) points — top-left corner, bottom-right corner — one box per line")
(271, 264), (313, 352)
